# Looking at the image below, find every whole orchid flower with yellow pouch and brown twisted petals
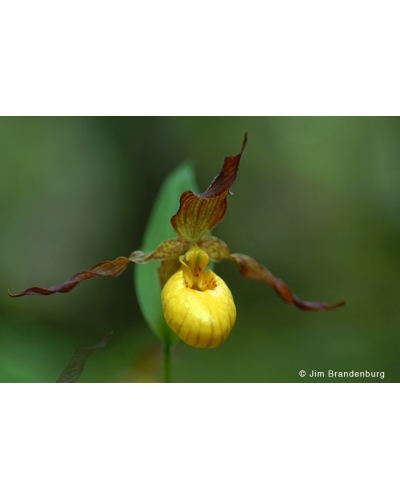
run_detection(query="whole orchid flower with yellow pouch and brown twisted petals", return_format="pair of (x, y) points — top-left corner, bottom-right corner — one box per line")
(9, 134), (345, 347)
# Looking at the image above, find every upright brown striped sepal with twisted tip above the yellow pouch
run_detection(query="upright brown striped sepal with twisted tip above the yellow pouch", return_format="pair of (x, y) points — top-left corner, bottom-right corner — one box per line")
(171, 134), (247, 242)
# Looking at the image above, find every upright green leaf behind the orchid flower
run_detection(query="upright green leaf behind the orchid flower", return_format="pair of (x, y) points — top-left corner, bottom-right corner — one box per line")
(134, 160), (199, 345)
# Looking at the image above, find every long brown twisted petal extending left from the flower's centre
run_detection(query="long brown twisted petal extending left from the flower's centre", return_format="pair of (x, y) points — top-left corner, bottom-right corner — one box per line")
(8, 238), (188, 298)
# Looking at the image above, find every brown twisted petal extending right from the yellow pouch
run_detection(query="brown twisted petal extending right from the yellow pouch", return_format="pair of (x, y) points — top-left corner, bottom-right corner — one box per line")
(230, 253), (346, 311)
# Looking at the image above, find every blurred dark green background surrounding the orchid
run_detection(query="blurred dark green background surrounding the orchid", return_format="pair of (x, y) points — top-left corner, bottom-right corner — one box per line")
(0, 117), (400, 382)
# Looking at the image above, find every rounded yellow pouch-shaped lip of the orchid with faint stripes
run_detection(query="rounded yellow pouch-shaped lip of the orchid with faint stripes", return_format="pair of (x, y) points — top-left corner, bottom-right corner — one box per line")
(161, 246), (236, 347)
